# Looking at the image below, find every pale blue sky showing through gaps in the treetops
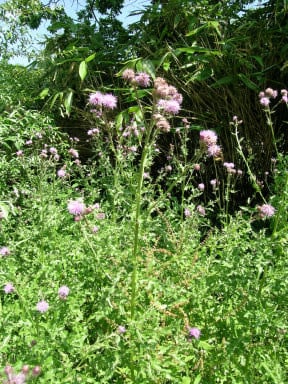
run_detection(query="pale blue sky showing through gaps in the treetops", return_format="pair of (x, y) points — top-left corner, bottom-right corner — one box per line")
(0, 0), (150, 65)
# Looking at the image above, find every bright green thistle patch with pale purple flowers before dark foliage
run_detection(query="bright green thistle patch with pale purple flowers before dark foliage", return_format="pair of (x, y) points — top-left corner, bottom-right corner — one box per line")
(0, 70), (288, 384)
